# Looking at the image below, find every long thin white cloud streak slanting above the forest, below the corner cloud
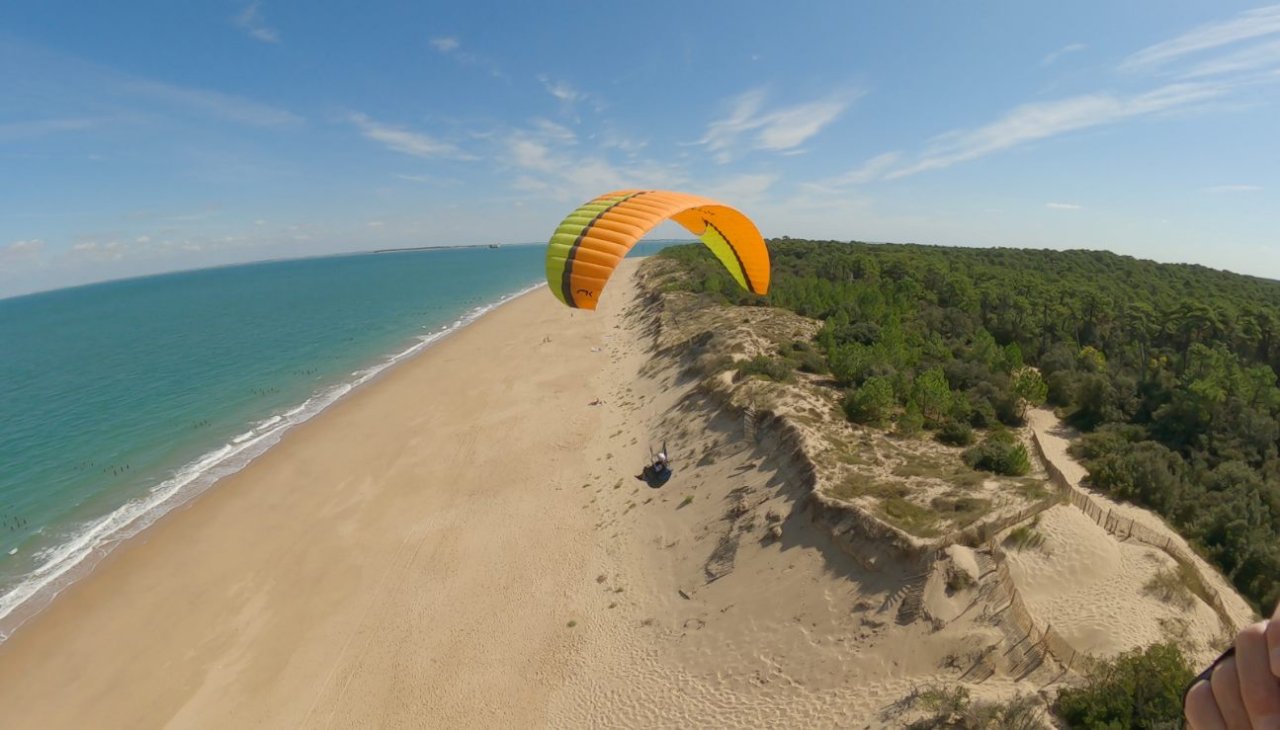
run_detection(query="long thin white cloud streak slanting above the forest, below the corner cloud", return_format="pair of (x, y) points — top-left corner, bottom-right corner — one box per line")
(886, 83), (1230, 179)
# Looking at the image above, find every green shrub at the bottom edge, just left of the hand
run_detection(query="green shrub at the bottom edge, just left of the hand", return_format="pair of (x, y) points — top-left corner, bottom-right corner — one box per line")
(1053, 643), (1196, 730)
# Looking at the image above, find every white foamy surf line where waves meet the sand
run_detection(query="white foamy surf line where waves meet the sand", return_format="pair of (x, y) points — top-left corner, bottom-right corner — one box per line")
(0, 282), (547, 647)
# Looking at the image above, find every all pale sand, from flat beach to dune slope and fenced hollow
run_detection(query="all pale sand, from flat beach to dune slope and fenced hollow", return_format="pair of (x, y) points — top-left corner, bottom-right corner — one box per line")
(0, 261), (1244, 729)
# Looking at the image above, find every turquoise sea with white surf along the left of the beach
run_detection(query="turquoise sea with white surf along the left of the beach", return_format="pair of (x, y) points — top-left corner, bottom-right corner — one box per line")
(0, 241), (669, 640)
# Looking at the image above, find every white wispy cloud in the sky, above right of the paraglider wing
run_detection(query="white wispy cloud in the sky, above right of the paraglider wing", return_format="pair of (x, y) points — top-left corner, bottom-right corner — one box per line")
(698, 90), (861, 164)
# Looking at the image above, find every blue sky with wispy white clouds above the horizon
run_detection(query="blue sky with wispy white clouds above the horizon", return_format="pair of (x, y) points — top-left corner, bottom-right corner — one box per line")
(0, 0), (1280, 296)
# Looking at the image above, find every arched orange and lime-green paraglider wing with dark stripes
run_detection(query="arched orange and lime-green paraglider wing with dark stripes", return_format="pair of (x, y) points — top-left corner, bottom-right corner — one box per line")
(547, 190), (769, 309)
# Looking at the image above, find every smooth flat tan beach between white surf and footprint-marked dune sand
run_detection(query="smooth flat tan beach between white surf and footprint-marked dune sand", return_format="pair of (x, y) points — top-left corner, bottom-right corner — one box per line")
(0, 261), (645, 727)
